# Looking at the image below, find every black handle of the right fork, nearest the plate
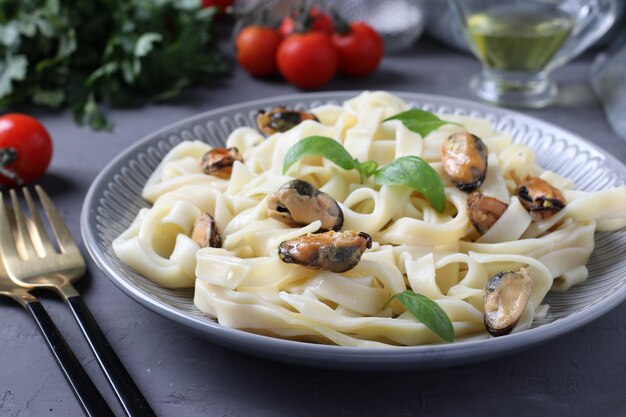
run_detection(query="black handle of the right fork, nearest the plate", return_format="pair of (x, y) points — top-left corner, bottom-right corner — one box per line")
(67, 295), (156, 417)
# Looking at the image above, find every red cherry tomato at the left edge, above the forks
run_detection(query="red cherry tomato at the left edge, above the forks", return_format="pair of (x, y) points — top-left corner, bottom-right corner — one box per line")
(0, 113), (52, 185)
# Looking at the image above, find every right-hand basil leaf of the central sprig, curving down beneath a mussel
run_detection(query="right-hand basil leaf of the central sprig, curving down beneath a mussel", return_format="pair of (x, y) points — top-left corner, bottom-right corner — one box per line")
(374, 155), (446, 213)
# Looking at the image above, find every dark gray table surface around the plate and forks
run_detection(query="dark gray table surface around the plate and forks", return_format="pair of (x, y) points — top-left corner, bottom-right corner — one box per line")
(0, 39), (626, 417)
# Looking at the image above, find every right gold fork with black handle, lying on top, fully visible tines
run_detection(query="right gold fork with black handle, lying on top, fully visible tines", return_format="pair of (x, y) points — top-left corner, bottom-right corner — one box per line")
(0, 186), (155, 417)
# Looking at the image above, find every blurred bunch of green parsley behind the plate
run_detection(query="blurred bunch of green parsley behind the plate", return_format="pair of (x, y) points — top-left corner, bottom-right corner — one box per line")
(0, 0), (228, 129)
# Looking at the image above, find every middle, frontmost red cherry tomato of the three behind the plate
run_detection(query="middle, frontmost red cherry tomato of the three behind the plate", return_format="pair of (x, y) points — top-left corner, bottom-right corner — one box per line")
(276, 32), (338, 89)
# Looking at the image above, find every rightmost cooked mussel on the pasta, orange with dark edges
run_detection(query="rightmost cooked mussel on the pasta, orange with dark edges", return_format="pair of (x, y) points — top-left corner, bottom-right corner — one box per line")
(517, 176), (565, 221)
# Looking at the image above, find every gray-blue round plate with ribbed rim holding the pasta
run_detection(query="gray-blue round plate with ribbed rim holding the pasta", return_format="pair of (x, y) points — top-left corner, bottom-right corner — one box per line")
(81, 91), (626, 371)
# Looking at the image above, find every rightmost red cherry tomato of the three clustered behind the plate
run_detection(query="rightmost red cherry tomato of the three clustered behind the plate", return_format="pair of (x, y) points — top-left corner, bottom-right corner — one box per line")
(333, 22), (383, 77)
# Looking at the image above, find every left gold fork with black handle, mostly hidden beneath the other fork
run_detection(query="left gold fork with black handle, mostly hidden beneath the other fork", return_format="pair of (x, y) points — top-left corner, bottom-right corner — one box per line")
(0, 204), (113, 417)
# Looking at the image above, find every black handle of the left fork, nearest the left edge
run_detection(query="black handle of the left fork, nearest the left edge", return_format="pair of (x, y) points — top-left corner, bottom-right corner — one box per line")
(26, 301), (115, 417)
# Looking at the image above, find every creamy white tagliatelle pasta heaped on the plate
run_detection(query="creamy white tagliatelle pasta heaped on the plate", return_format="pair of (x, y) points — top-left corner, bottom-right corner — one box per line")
(113, 92), (626, 347)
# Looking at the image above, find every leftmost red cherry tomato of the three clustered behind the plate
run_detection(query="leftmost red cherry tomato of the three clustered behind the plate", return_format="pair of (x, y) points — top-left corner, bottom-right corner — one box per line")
(235, 25), (282, 77)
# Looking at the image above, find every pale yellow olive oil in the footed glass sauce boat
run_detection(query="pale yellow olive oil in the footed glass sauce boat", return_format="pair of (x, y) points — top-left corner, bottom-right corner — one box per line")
(466, 3), (575, 73)
